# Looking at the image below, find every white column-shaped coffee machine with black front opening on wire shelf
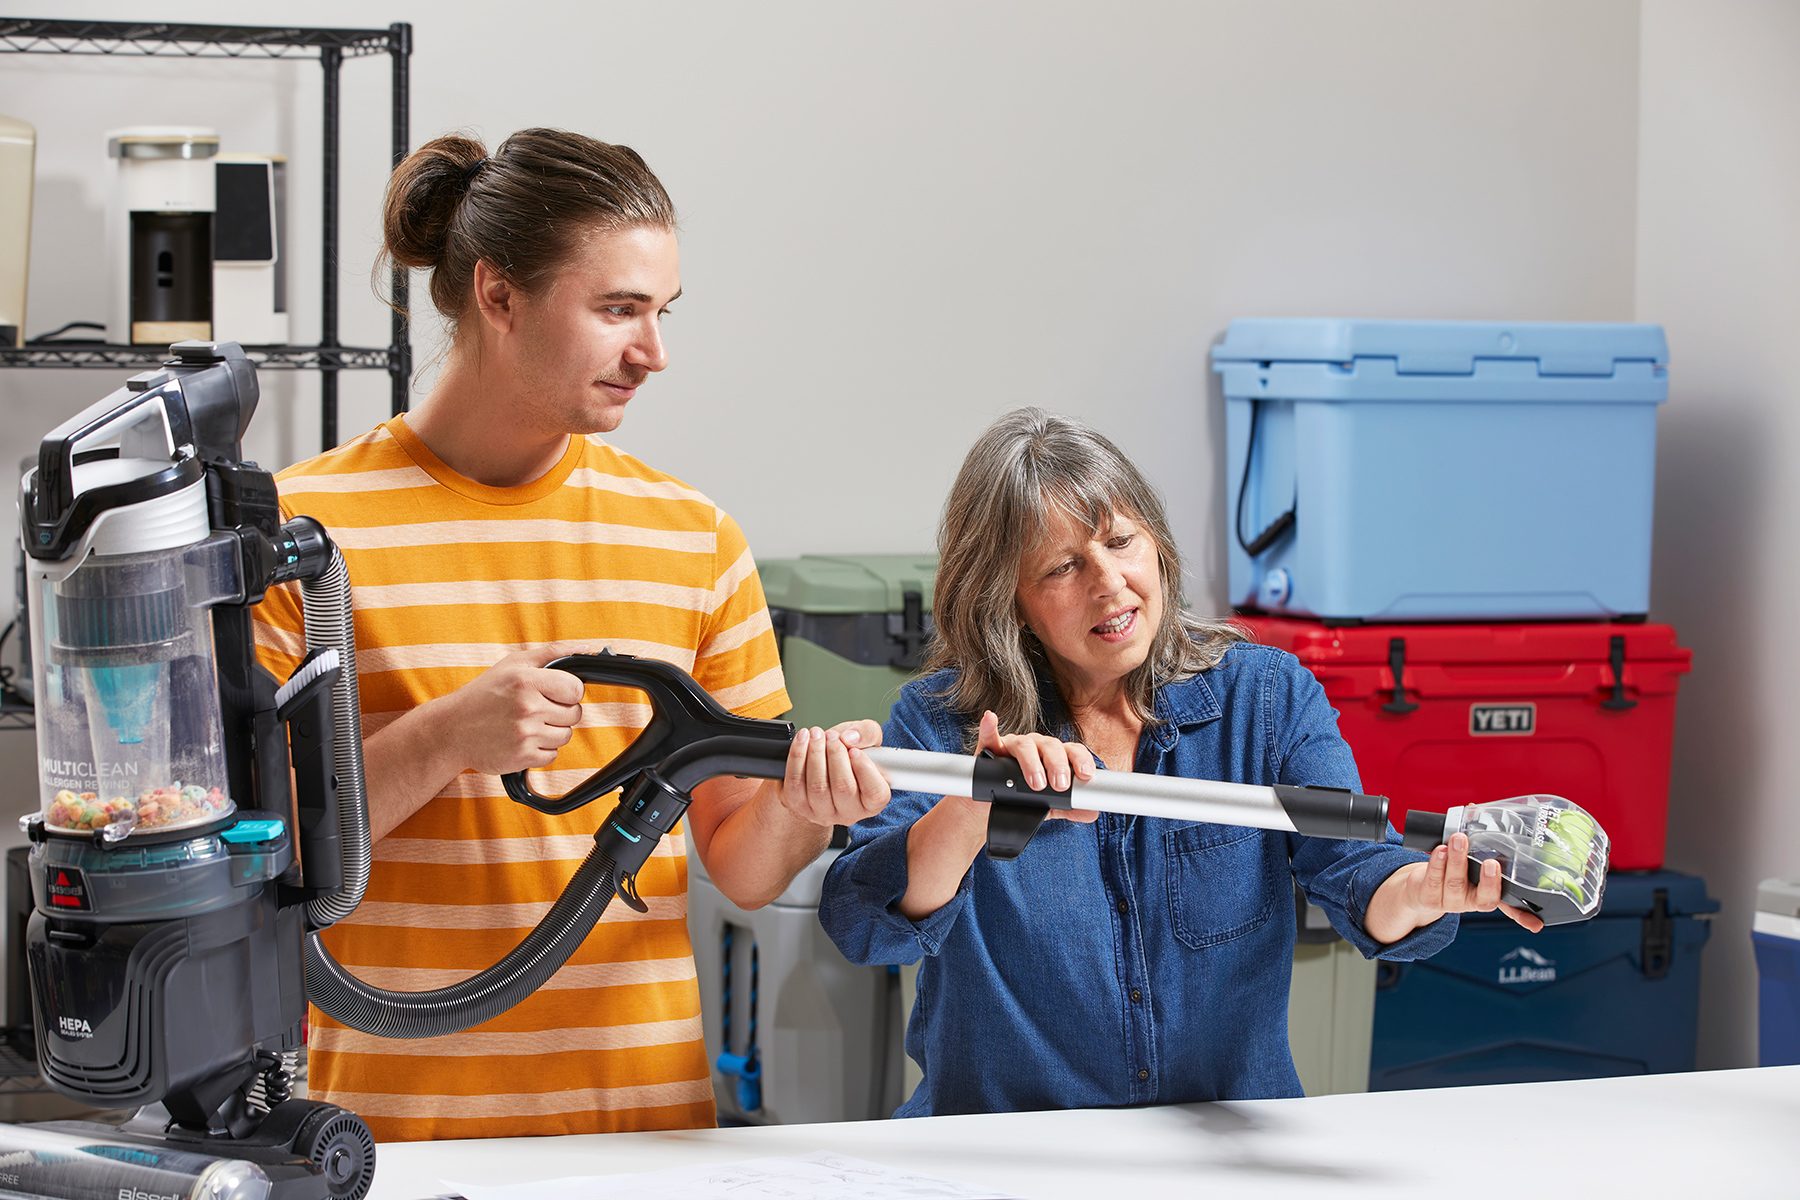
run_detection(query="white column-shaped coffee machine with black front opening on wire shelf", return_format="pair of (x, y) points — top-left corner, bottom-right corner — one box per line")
(106, 126), (220, 345)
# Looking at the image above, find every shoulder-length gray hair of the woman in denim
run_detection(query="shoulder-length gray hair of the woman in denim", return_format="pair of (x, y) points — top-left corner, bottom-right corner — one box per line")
(925, 408), (1244, 743)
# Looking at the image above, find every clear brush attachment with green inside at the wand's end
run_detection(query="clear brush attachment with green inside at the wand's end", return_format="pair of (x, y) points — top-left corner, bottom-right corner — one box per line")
(1404, 795), (1611, 925)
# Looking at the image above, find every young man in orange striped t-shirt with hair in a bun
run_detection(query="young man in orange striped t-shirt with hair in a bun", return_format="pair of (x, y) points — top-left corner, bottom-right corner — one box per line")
(257, 130), (887, 1141)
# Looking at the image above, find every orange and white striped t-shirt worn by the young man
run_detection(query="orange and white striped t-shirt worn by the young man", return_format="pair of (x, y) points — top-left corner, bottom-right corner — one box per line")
(256, 417), (790, 1141)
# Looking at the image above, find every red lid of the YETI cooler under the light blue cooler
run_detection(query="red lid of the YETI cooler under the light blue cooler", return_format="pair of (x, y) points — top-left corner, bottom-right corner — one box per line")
(1238, 617), (1694, 669)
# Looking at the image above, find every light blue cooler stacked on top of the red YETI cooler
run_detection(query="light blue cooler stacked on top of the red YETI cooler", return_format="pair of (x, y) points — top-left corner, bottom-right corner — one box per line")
(1213, 318), (1669, 621)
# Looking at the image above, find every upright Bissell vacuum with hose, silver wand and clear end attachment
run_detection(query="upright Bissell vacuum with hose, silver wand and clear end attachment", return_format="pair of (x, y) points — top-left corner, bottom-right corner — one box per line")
(0, 342), (1607, 1200)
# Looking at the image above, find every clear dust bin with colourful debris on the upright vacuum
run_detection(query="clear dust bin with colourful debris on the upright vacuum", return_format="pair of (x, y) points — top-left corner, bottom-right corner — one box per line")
(32, 543), (234, 840)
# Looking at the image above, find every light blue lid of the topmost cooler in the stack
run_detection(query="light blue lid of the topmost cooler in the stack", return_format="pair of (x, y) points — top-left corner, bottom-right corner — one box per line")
(1213, 317), (1669, 376)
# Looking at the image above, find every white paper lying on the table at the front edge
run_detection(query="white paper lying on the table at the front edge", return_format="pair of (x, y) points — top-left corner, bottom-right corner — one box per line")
(445, 1153), (1013, 1200)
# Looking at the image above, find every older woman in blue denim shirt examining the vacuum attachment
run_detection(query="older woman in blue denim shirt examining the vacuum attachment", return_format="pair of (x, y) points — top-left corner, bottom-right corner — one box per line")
(819, 408), (1539, 1115)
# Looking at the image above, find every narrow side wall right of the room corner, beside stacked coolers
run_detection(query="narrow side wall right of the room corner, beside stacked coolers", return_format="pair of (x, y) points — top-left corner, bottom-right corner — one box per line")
(1636, 0), (1800, 1067)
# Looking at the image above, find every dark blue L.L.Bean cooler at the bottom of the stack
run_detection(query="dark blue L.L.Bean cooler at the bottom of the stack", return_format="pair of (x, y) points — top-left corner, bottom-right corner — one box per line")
(1370, 871), (1719, 1092)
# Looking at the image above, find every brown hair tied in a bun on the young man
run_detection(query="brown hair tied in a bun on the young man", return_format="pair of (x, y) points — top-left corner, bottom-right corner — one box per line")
(376, 130), (675, 326)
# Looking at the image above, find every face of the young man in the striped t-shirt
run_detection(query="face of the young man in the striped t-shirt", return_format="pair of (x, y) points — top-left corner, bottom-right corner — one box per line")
(515, 225), (680, 434)
